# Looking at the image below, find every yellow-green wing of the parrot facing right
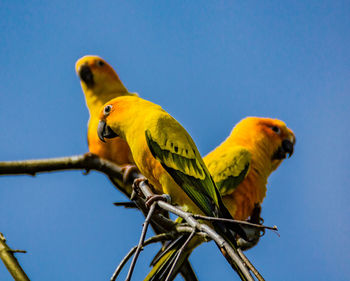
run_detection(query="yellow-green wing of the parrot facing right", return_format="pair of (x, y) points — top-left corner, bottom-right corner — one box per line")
(206, 146), (251, 196)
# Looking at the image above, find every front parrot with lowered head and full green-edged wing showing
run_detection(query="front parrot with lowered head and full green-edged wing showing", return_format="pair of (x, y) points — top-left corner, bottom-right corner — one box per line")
(98, 96), (247, 280)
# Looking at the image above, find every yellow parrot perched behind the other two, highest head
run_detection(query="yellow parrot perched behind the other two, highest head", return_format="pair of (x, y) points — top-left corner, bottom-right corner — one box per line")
(75, 56), (137, 196)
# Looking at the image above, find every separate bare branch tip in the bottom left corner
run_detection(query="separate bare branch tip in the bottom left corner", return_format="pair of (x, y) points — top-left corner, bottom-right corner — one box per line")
(0, 232), (30, 281)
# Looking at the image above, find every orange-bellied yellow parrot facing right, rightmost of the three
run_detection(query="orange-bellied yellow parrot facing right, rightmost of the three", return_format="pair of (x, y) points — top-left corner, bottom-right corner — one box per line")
(145, 117), (295, 280)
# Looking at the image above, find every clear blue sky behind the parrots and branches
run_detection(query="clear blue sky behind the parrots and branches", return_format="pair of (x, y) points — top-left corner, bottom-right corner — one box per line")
(0, 0), (350, 281)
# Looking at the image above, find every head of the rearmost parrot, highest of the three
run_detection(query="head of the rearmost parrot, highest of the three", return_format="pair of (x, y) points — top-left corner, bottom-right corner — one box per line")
(75, 56), (126, 93)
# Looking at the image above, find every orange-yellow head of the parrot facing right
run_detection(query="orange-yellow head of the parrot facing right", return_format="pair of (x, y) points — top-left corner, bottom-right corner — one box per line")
(228, 117), (296, 172)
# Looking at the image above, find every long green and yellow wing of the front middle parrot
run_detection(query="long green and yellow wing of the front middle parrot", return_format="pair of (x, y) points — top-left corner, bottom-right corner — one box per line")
(145, 112), (246, 237)
